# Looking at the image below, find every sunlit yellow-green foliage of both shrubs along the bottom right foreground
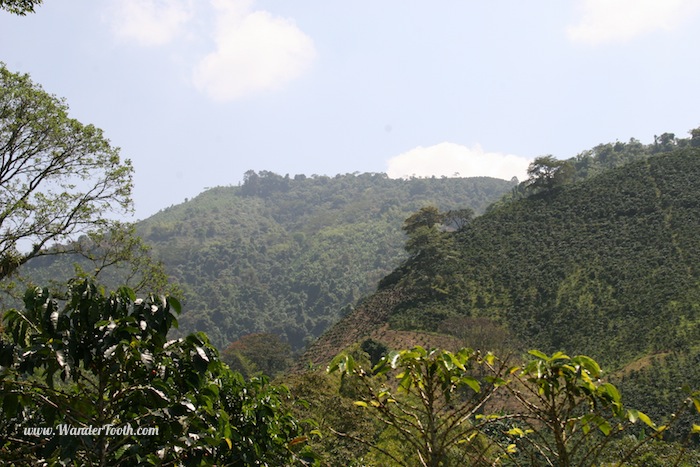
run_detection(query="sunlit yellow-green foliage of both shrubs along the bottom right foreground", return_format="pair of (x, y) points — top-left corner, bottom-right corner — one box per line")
(328, 347), (700, 467)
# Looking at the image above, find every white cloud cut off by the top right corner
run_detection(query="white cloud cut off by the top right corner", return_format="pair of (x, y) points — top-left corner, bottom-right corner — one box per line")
(567, 0), (700, 45)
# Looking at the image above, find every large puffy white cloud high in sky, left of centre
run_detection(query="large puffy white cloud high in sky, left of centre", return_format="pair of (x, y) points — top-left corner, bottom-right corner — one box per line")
(193, 0), (316, 101)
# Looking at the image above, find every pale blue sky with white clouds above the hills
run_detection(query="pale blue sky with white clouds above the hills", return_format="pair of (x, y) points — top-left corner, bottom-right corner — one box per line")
(0, 0), (700, 219)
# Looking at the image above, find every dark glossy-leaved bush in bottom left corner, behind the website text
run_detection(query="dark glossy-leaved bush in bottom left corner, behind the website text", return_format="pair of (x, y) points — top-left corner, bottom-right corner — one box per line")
(0, 280), (312, 465)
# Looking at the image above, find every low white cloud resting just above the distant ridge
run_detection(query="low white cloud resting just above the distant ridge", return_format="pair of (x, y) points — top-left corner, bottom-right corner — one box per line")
(387, 143), (531, 181)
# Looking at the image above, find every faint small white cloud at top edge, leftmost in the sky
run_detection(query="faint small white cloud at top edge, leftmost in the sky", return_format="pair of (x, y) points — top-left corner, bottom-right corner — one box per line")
(107, 0), (192, 46)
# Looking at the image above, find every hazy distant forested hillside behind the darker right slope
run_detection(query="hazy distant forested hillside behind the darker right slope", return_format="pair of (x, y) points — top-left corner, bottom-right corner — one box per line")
(138, 171), (514, 348)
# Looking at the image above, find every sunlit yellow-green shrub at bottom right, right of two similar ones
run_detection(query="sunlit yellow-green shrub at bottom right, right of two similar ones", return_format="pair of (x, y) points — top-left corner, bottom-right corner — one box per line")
(498, 350), (666, 467)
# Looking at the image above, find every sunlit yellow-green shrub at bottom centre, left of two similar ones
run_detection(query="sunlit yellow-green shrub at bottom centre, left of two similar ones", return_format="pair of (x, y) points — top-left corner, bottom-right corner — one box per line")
(328, 346), (506, 467)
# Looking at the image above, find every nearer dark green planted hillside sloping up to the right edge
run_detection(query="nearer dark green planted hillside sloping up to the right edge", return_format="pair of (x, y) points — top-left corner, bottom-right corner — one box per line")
(304, 145), (700, 436)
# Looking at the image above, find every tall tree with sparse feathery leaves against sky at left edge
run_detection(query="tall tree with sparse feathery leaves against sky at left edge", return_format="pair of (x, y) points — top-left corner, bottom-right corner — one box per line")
(0, 62), (132, 279)
